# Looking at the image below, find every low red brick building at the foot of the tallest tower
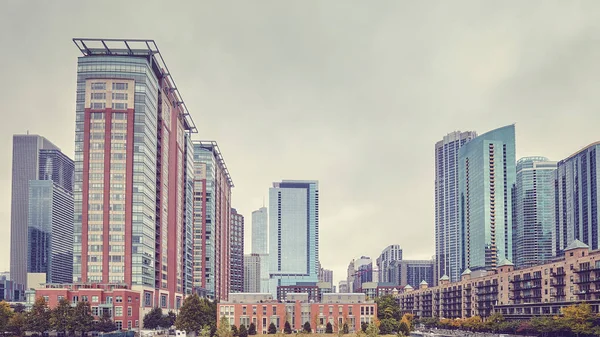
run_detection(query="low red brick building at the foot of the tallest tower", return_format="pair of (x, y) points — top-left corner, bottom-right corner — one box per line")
(35, 284), (142, 330)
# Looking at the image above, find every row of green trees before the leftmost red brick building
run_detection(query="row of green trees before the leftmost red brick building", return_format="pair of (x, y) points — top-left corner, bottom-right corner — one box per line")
(0, 297), (117, 336)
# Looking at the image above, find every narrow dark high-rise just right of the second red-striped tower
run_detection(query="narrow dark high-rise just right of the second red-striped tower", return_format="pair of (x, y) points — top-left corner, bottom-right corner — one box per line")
(229, 208), (244, 293)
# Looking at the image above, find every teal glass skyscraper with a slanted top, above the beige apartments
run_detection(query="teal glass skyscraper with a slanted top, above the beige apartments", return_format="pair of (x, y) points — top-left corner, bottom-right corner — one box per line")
(458, 125), (516, 270)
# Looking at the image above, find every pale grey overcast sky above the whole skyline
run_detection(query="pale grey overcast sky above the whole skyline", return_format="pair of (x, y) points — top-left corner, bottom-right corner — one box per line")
(0, 0), (600, 283)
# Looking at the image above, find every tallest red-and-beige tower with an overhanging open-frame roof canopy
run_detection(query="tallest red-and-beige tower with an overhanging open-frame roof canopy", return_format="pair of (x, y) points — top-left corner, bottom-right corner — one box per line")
(73, 39), (196, 309)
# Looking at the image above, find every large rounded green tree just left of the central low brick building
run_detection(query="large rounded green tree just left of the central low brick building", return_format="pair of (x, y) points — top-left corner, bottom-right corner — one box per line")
(175, 294), (217, 334)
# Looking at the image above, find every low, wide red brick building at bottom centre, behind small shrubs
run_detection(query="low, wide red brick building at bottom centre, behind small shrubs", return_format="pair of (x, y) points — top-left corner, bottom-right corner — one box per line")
(217, 293), (377, 334)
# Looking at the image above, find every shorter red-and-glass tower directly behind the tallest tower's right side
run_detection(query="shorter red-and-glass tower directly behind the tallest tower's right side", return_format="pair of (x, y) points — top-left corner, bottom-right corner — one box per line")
(193, 141), (233, 300)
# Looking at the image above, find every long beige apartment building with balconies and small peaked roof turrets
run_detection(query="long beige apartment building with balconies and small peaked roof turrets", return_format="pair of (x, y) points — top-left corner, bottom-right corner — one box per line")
(396, 240), (600, 318)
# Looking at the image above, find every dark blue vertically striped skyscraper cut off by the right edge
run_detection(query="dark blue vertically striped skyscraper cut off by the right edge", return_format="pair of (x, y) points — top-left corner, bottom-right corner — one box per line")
(552, 142), (600, 255)
